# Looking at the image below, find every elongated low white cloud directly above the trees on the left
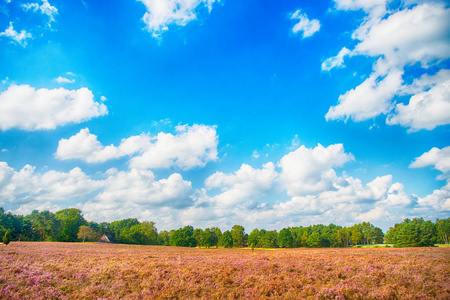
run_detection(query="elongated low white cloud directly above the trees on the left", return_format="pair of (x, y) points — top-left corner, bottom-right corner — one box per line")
(0, 162), (193, 221)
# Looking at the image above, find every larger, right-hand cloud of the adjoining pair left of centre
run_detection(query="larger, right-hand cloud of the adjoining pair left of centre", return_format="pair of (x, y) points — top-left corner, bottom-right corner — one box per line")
(130, 124), (218, 170)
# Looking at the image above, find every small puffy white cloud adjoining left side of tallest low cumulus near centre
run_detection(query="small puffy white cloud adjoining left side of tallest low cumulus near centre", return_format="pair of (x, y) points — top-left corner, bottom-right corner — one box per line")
(205, 163), (278, 207)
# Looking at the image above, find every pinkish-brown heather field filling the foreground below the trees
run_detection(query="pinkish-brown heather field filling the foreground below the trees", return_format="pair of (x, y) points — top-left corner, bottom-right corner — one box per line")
(0, 242), (450, 299)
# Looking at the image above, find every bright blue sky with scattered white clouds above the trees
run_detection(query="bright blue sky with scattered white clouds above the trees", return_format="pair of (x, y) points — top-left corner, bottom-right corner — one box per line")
(0, 0), (450, 231)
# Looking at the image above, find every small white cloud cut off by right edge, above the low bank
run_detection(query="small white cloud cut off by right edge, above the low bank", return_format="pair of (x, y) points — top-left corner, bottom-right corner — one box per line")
(409, 146), (450, 175)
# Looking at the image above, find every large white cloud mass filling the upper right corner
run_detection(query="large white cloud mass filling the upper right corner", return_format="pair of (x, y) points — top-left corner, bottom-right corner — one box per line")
(322, 0), (450, 131)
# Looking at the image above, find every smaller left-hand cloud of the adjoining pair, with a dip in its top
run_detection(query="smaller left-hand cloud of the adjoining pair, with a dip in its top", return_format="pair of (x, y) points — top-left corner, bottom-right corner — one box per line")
(56, 128), (151, 163)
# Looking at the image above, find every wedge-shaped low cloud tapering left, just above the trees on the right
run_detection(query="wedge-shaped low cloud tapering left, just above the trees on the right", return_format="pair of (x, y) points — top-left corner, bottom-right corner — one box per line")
(246, 175), (411, 226)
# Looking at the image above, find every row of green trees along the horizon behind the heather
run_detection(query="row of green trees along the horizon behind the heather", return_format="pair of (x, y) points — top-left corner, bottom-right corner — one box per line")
(0, 207), (450, 248)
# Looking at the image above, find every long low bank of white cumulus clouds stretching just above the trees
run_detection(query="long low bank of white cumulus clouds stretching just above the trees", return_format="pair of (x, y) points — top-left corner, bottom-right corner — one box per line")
(4, 138), (450, 230)
